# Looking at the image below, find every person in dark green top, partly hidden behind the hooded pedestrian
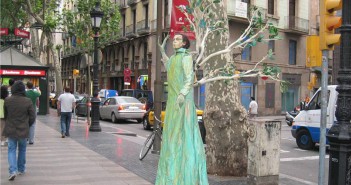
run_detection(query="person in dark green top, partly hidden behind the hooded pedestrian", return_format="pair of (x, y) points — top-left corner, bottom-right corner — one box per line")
(26, 81), (41, 145)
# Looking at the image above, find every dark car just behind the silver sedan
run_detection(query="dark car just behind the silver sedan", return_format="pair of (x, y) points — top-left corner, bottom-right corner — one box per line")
(121, 89), (154, 110)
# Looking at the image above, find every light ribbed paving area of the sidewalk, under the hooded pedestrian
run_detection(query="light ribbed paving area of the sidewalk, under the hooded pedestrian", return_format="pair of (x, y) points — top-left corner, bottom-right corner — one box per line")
(1, 120), (151, 185)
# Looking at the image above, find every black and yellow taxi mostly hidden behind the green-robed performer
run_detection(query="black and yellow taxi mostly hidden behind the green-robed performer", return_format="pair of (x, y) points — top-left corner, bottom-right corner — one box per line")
(143, 102), (206, 143)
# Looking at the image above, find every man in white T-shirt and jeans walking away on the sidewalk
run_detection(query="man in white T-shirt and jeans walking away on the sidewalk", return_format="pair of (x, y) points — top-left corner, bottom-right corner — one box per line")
(57, 87), (76, 138)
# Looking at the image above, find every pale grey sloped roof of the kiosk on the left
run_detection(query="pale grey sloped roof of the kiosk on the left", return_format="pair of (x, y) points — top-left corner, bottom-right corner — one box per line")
(0, 47), (45, 67)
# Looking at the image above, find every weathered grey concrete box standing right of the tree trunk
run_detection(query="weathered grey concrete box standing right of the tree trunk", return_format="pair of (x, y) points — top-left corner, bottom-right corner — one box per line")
(247, 118), (281, 185)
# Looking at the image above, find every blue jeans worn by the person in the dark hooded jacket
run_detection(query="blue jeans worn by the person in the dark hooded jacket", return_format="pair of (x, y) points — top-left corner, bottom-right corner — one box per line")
(8, 138), (27, 175)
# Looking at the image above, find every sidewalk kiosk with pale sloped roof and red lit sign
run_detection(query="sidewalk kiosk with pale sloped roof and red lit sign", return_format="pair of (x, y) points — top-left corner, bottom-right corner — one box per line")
(0, 47), (49, 115)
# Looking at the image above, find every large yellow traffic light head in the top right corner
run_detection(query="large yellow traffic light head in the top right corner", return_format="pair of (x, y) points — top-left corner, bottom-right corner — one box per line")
(319, 0), (342, 50)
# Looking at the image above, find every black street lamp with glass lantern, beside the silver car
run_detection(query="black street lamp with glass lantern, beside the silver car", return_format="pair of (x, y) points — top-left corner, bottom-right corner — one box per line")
(89, 2), (104, 132)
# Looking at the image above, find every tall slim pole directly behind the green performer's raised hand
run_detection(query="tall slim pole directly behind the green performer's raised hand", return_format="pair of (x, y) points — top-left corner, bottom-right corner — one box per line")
(151, 0), (163, 154)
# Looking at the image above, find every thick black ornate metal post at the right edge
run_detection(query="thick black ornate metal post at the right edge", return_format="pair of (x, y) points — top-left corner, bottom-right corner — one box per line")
(327, 0), (351, 185)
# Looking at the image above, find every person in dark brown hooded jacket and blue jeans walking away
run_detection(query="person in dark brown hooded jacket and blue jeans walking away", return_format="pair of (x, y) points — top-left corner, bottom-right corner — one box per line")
(3, 81), (35, 180)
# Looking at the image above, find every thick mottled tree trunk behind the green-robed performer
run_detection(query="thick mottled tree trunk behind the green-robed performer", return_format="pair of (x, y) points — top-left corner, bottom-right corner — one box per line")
(204, 2), (248, 177)
